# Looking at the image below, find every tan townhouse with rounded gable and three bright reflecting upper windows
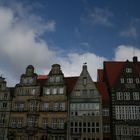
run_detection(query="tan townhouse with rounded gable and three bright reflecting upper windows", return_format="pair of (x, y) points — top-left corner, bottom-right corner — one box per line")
(40, 64), (67, 140)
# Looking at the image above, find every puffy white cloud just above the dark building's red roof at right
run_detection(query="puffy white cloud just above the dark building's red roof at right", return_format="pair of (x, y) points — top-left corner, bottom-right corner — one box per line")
(114, 45), (140, 61)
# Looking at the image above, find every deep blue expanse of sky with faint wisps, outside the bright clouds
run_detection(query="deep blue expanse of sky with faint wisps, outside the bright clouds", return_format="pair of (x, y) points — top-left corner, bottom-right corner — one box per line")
(18, 0), (140, 59)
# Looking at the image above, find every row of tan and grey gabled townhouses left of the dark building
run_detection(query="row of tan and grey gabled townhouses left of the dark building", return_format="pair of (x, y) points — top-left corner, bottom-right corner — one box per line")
(0, 64), (109, 140)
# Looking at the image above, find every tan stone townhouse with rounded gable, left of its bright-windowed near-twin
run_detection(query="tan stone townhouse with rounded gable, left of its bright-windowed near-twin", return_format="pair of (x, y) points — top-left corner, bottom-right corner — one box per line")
(9, 65), (41, 140)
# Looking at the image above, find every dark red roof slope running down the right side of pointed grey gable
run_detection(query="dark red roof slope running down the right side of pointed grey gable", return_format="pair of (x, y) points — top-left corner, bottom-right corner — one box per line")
(95, 82), (109, 103)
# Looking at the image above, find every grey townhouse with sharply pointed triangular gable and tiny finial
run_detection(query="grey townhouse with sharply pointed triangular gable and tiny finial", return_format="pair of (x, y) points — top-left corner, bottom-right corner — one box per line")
(68, 64), (103, 140)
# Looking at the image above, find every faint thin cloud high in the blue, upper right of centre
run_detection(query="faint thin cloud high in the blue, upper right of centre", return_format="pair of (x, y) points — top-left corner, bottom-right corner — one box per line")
(81, 7), (113, 26)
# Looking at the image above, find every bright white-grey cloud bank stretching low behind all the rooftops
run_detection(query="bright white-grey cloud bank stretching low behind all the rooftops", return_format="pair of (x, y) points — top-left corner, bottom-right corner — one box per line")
(0, 6), (140, 86)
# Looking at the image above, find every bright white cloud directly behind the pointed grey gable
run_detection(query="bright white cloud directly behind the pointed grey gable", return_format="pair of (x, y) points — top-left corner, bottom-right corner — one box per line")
(60, 53), (106, 80)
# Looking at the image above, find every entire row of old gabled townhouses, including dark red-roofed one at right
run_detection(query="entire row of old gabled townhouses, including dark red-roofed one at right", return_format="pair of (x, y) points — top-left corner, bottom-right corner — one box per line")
(0, 57), (140, 140)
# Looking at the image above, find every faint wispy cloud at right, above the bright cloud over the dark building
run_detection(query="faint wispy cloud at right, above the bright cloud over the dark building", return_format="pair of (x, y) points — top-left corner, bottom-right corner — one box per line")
(120, 27), (138, 38)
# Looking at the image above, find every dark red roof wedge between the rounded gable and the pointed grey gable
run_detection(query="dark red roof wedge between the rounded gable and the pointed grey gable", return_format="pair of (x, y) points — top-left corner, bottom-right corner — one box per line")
(65, 76), (79, 95)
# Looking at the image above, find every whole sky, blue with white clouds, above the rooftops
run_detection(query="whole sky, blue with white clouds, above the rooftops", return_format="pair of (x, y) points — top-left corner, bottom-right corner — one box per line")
(0, 0), (140, 86)
